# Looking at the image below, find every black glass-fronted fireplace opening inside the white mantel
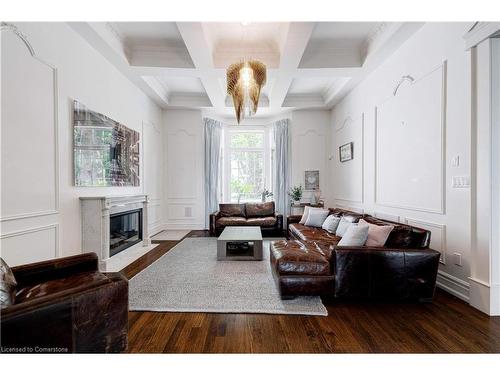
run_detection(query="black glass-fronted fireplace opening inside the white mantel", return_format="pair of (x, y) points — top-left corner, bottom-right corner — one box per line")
(109, 208), (142, 257)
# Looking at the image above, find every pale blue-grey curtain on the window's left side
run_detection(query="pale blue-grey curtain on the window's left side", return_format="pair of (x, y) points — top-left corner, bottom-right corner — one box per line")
(203, 118), (222, 228)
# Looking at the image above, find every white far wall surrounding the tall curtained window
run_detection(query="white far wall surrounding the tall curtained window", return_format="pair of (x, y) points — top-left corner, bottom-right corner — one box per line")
(163, 109), (330, 229)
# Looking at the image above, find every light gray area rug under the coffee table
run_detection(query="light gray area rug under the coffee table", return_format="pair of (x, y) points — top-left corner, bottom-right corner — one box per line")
(129, 238), (328, 316)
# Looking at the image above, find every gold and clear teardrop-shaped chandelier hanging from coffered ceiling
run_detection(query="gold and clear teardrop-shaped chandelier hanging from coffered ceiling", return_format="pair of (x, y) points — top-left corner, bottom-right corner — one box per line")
(226, 60), (266, 124)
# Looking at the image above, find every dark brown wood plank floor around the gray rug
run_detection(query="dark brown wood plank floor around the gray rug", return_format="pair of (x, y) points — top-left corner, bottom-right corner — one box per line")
(122, 231), (500, 353)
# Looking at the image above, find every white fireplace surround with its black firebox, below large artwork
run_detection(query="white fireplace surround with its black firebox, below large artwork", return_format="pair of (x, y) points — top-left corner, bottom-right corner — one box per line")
(80, 195), (151, 270)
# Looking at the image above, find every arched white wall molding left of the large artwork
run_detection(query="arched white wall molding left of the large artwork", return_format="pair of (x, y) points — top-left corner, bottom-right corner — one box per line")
(0, 22), (60, 222)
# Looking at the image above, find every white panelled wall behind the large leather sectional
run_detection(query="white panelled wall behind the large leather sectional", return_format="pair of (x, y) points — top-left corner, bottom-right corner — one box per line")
(328, 23), (471, 300)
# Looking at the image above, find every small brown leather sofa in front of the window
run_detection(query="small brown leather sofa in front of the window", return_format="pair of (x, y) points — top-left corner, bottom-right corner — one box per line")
(210, 202), (283, 236)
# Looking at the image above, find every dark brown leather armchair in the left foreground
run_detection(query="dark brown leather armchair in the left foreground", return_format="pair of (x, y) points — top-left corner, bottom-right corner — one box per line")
(1, 253), (128, 353)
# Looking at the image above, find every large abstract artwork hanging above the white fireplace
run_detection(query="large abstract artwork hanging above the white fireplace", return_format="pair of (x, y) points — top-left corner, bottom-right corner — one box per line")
(73, 100), (140, 186)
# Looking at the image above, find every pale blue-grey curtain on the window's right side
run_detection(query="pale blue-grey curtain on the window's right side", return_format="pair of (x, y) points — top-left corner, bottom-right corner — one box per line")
(273, 119), (290, 223)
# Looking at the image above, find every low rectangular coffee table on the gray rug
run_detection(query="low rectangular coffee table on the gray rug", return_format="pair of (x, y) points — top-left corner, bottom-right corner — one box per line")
(217, 226), (262, 260)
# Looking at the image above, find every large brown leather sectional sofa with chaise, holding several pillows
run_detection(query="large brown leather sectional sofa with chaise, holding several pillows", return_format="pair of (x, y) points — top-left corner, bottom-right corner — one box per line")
(270, 209), (440, 301)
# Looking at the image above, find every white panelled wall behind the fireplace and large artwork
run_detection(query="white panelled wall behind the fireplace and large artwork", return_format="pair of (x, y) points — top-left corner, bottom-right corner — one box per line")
(1, 23), (163, 265)
